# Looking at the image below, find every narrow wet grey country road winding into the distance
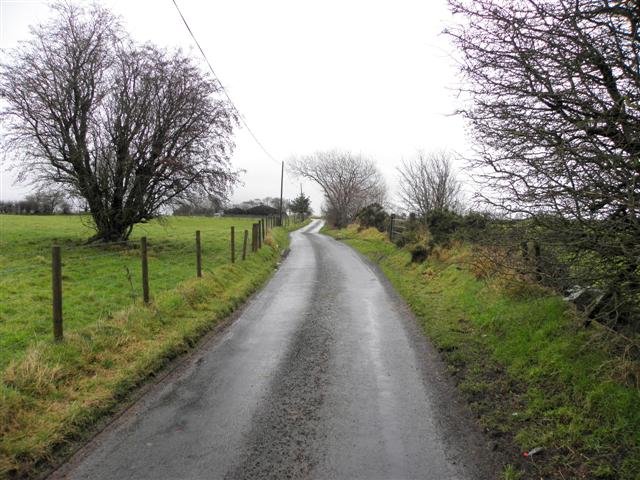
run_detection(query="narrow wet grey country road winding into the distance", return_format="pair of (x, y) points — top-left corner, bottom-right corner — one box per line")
(52, 221), (497, 480)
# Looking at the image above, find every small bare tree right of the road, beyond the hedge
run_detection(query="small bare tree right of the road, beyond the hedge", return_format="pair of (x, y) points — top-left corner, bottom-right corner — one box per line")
(398, 150), (460, 217)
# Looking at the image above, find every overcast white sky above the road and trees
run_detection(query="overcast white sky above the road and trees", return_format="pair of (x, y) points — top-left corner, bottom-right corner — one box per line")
(0, 0), (468, 211)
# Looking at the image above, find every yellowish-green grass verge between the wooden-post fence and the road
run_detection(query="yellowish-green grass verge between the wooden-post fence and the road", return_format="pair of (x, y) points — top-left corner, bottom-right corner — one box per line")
(0, 218), (308, 478)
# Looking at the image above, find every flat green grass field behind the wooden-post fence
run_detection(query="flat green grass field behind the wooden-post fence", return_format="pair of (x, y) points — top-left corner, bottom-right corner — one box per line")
(0, 215), (260, 369)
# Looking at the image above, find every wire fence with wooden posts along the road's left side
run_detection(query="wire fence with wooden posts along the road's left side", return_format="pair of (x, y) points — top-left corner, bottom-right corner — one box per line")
(0, 212), (304, 350)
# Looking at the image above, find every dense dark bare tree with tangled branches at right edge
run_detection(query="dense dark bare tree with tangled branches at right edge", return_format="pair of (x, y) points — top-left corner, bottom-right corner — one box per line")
(449, 0), (640, 326)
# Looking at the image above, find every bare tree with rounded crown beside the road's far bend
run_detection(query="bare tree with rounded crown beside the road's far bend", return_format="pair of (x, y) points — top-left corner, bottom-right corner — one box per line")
(289, 150), (386, 227)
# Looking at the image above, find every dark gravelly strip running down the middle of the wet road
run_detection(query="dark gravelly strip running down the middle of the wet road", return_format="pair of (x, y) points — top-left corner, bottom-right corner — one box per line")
(225, 239), (340, 480)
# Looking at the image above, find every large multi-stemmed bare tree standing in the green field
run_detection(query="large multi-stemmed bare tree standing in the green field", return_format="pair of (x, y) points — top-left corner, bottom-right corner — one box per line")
(0, 3), (236, 241)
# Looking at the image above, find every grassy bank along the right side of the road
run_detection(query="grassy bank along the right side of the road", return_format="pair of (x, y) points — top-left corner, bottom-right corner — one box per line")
(326, 228), (640, 480)
